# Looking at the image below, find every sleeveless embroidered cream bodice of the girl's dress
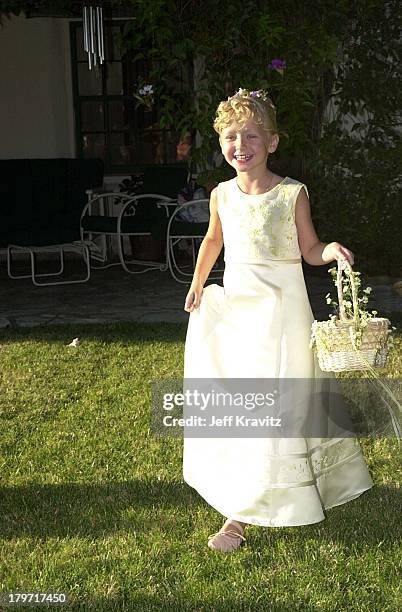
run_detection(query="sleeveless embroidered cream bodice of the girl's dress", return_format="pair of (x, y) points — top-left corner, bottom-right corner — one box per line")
(217, 176), (308, 263)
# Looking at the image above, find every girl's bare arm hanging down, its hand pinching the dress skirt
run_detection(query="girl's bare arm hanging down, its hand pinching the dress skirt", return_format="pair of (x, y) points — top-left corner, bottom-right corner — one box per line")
(184, 187), (223, 312)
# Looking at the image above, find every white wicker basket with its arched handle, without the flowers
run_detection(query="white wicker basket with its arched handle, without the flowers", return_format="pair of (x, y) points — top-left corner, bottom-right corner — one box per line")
(312, 261), (390, 372)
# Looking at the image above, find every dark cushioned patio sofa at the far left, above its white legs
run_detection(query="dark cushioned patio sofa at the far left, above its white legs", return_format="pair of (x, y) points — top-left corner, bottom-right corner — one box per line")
(0, 158), (103, 248)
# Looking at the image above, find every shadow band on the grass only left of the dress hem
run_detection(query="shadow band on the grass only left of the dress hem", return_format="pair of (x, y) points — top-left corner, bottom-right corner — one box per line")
(0, 480), (199, 539)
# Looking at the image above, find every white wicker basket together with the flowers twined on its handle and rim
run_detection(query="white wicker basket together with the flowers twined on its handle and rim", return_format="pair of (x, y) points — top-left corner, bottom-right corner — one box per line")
(310, 261), (395, 372)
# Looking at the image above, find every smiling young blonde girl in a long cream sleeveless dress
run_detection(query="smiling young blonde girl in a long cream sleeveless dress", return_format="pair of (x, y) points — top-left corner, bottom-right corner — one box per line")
(183, 89), (373, 552)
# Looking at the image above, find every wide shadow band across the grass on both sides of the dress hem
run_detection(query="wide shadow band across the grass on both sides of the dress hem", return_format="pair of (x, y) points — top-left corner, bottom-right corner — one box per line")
(0, 480), (400, 547)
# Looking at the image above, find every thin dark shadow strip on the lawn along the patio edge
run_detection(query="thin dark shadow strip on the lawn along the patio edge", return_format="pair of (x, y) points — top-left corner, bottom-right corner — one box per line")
(0, 323), (187, 346)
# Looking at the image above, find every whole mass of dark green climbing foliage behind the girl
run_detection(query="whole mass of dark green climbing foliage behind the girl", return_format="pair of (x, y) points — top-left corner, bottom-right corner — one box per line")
(116, 0), (401, 274)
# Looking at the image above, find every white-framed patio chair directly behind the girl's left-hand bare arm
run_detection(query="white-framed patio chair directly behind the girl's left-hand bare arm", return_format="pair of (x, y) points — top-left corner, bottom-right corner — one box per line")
(166, 198), (223, 284)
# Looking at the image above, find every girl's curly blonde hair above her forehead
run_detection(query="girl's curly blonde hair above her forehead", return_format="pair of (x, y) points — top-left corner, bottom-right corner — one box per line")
(213, 92), (278, 136)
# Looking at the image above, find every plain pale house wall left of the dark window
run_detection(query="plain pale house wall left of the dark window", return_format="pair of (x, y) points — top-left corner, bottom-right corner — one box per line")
(0, 15), (75, 159)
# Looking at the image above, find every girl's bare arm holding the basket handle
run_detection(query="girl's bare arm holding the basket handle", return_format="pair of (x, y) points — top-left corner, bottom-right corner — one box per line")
(296, 188), (354, 266)
